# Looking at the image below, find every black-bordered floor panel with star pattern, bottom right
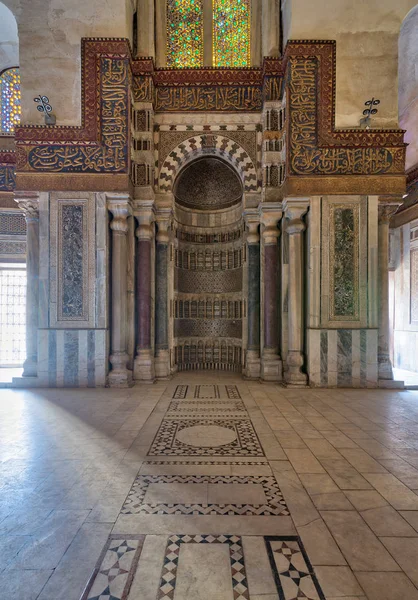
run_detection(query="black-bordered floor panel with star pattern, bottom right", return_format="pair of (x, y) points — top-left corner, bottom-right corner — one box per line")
(264, 536), (325, 600)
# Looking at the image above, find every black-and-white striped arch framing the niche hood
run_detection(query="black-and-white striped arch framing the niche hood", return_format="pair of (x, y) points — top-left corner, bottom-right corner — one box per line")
(158, 134), (259, 192)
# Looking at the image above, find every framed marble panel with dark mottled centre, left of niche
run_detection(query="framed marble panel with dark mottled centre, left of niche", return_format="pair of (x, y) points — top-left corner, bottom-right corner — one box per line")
(50, 194), (96, 329)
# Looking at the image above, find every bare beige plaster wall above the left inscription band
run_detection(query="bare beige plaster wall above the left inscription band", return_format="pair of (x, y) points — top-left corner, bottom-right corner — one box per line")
(4, 0), (133, 125)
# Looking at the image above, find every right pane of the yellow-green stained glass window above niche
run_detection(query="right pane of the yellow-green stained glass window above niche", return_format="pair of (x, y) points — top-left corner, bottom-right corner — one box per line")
(213, 0), (251, 67)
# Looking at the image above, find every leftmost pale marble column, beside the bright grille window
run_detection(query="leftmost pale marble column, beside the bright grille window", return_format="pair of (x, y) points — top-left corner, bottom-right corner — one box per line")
(15, 192), (39, 377)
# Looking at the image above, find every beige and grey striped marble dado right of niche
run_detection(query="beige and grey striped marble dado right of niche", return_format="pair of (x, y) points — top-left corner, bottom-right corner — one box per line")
(307, 329), (378, 388)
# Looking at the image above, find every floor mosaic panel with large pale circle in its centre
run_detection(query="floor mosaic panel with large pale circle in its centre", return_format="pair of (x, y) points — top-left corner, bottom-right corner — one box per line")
(148, 419), (264, 456)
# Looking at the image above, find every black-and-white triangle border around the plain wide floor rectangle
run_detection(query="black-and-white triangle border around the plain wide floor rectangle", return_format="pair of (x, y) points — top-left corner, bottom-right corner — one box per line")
(121, 475), (290, 517)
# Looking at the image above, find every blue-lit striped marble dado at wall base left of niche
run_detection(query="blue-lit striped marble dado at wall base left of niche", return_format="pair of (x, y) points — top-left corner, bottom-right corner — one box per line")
(38, 329), (108, 387)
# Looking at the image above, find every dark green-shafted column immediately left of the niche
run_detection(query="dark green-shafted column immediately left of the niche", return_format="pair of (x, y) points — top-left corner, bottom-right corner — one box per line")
(155, 209), (171, 379)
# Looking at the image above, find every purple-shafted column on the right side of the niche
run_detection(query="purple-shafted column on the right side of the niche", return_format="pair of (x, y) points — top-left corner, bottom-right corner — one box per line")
(261, 207), (282, 381)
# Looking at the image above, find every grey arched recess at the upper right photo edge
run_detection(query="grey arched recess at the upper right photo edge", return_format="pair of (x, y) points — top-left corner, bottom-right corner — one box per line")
(398, 5), (418, 169)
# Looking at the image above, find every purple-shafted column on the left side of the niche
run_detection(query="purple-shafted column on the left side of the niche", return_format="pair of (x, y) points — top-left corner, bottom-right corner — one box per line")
(134, 209), (155, 383)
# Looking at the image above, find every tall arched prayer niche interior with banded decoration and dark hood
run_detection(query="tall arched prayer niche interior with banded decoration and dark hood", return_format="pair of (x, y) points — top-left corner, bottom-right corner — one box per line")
(173, 155), (244, 372)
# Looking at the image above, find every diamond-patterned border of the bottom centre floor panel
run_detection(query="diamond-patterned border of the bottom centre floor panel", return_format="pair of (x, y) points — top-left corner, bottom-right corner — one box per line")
(157, 535), (250, 600)
